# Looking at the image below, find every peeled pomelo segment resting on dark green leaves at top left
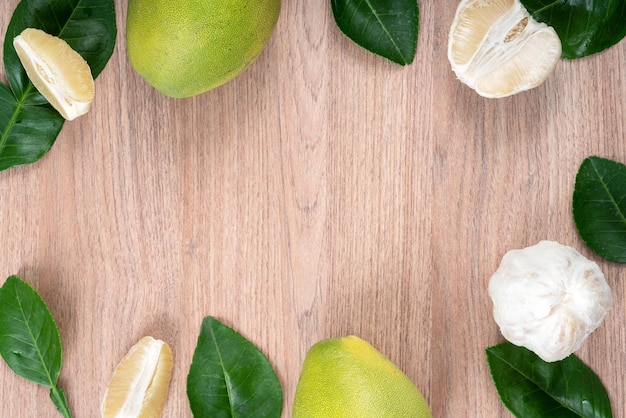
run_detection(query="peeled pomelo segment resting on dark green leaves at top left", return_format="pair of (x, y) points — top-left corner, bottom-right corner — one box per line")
(13, 28), (95, 120)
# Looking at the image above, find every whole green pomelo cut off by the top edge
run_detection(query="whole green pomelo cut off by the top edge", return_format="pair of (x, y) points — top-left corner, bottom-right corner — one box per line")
(126, 0), (281, 98)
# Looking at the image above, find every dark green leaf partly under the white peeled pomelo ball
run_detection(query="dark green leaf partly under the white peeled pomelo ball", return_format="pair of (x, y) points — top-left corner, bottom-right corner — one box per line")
(486, 342), (613, 418)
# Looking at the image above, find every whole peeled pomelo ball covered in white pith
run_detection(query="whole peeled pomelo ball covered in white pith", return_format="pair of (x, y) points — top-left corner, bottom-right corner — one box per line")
(489, 241), (613, 362)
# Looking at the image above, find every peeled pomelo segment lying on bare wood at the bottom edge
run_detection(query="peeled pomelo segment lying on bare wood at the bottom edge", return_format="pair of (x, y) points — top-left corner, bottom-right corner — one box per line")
(100, 337), (173, 418)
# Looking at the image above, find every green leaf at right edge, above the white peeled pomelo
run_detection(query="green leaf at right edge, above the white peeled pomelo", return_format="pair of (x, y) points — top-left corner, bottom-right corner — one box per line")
(572, 156), (626, 263)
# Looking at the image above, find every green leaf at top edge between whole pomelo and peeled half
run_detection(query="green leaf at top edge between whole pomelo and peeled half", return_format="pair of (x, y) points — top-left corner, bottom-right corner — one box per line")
(331, 0), (419, 65)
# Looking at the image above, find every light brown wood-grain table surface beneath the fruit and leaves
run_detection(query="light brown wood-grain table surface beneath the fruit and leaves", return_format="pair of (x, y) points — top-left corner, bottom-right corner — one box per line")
(0, 0), (626, 418)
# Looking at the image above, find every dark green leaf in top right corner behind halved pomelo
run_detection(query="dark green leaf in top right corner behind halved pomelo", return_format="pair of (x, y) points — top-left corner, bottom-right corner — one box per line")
(521, 0), (626, 59)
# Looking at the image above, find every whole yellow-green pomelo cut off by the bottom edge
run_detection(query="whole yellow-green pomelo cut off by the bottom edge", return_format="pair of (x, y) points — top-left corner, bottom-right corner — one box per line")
(293, 336), (432, 418)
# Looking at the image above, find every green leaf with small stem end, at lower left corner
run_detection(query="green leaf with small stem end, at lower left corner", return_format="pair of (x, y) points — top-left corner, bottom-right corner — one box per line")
(0, 276), (70, 417)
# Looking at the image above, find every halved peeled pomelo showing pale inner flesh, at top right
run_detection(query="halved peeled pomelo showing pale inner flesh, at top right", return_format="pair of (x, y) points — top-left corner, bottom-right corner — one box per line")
(448, 0), (561, 98)
